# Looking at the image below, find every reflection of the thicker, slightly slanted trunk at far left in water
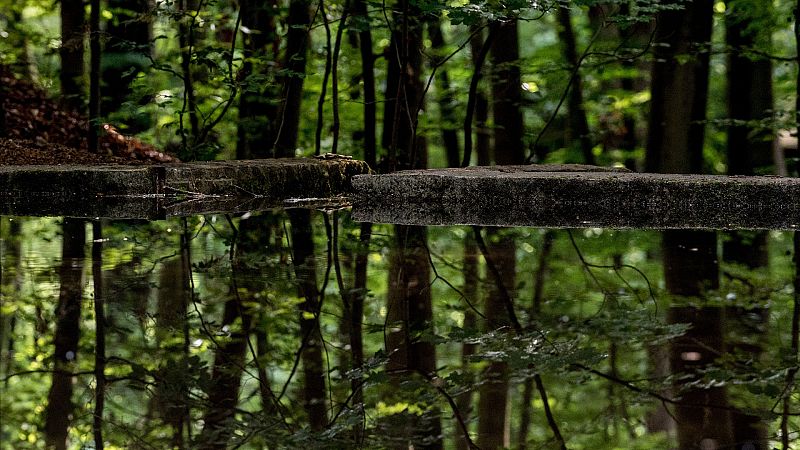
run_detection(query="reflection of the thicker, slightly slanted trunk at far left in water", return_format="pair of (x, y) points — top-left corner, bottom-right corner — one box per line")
(44, 219), (86, 450)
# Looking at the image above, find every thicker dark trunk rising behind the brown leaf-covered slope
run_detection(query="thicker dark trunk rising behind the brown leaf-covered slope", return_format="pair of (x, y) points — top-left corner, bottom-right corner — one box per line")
(58, 0), (86, 111)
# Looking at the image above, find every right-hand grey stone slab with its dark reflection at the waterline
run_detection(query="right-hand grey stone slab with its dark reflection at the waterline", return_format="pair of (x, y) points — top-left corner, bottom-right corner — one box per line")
(353, 166), (800, 229)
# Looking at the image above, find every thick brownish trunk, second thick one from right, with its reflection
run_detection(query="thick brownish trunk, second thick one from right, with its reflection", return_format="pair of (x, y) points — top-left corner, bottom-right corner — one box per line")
(646, 0), (733, 449)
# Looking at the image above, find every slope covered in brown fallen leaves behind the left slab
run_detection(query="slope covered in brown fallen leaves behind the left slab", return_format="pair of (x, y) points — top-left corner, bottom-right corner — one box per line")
(0, 66), (178, 165)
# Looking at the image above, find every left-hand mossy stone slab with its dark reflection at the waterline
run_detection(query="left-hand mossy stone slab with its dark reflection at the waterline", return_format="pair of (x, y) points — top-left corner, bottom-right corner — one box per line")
(0, 159), (369, 218)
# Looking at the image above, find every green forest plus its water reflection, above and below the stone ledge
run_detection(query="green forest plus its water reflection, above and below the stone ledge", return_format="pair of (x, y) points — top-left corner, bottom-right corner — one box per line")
(0, 0), (800, 450)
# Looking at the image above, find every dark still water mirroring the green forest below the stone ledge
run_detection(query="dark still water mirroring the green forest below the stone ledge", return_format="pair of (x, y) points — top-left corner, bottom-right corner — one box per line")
(0, 210), (800, 449)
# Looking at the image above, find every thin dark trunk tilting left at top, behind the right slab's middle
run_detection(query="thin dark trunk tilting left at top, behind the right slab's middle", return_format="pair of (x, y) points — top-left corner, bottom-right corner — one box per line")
(556, 6), (595, 164)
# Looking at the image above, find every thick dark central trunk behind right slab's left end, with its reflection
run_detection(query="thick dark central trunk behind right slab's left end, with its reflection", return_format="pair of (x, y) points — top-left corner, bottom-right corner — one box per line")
(382, 0), (442, 449)
